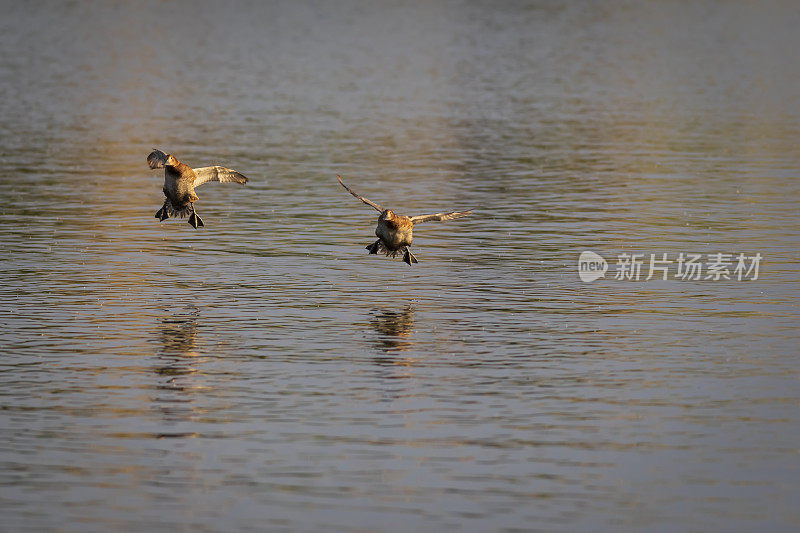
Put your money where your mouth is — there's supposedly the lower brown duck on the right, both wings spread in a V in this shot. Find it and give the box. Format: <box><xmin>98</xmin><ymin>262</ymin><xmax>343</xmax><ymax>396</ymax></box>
<box><xmin>336</xmin><ymin>174</ymin><xmax>472</xmax><ymax>266</ymax></box>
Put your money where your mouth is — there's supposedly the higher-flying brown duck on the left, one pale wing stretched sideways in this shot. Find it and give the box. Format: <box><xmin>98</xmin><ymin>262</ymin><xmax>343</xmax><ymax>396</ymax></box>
<box><xmin>147</xmin><ymin>148</ymin><xmax>247</xmax><ymax>229</ymax></box>
